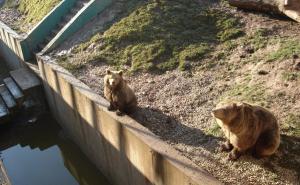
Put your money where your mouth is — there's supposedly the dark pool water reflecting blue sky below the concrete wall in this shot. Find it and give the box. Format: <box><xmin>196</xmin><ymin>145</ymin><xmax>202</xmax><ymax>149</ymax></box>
<box><xmin>0</xmin><ymin>115</ymin><xmax>109</xmax><ymax>185</ymax></box>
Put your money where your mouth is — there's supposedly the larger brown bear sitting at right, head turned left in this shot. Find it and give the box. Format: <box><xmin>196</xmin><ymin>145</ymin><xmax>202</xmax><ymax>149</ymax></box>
<box><xmin>212</xmin><ymin>103</ymin><xmax>280</xmax><ymax>160</ymax></box>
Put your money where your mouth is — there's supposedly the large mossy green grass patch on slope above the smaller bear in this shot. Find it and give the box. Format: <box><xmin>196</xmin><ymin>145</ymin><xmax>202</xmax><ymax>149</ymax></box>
<box><xmin>75</xmin><ymin>0</ymin><xmax>243</xmax><ymax>72</ymax></box>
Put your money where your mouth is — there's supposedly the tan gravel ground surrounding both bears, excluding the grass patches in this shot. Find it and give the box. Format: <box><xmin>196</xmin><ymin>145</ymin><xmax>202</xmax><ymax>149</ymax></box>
<box><xmin>51</xmin><ymin>1</ymin><xmax>300</xmax><ymax>185</ymax></box>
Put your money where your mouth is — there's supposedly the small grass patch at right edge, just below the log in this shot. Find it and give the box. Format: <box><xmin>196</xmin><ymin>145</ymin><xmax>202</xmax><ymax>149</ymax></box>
<box><xmin>267</xmin><ymin>39</ymin><xmax>300</xmax><ymax>62</ymax></box>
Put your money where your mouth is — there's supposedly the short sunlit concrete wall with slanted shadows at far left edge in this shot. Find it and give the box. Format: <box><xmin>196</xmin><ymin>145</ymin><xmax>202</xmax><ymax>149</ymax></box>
<box><xmin>0</xmin><ymin>21</ymin><xmax>24</xmax><ymax>69</ymax></box>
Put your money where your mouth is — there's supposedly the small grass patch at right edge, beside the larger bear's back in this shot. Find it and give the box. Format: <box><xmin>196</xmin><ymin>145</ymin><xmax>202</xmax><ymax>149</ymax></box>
<box><xmin>282</xmin><ymin>114</ymin><xmax>300</xmax><ymax>137</ymax></box>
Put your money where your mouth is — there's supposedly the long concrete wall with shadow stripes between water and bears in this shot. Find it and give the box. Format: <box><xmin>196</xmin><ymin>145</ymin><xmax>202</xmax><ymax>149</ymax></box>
<box><xmin>38</xmin><ymin>56</ymin><xmax>220</xmax><ymax>185</ymax></box>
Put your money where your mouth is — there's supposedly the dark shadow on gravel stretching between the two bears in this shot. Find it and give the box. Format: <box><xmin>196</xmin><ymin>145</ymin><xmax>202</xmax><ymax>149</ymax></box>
<box><xmin>130</xmin><ymin>107</ymin><xmax>221</xmax><ymax>152</ymax></box>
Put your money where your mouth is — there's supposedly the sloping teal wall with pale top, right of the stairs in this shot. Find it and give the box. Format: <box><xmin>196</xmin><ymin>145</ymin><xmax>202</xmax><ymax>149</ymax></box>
<box><xmin>41</xmin><ymin>0</ymin><xmax>112</xmax><ymax>53</ymax></box>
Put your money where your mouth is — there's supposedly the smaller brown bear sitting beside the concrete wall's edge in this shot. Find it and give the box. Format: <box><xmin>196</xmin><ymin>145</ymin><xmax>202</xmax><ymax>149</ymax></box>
<box><xmin>104</xmin><ymin>70</ymin><xmax>137</xmax><ymax>115</ymax></box>
